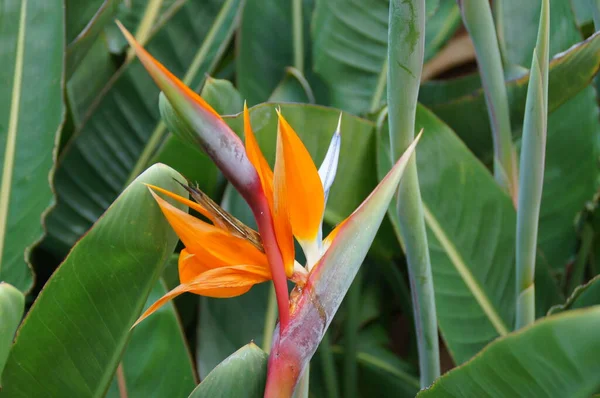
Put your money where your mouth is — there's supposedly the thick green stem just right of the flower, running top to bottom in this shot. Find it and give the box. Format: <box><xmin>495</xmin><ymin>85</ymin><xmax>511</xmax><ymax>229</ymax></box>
<box><xmin>387</xmin><ymin>0</ymin><xmax>440</xmax><ymax>388</ymax></box>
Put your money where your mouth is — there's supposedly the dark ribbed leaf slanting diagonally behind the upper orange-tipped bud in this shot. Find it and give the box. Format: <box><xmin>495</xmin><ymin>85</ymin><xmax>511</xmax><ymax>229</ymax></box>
<box><xmin>45</xmin><ymin>0</ymin><xmax>241</xmax><ymax>255</ymax></box>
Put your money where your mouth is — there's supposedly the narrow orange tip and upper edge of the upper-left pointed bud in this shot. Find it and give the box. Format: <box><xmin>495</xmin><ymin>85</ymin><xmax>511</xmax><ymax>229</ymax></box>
<box><xmin>116</xmin><ymin>21</ymin><xmax>222</xmax><ymax>120</ymax></box>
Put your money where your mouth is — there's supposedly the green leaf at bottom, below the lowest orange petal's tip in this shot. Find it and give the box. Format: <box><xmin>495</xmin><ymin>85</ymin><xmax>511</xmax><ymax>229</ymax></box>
<box><xmin>106</xmin><ymin>281</ymin><xmax>196</xmax><ymax>398</ymax></box>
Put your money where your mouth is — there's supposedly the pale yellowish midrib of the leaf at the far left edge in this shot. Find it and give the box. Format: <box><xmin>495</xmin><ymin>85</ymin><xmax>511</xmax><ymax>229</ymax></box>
<box><xmin>0</xmin><ymin>0</ymin><xmax>27</xmax><ymax>271</ymax></box>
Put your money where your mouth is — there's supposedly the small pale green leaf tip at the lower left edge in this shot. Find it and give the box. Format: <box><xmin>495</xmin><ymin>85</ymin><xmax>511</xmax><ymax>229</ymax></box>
<box><xmin>0</xmin><ymin>282</ymin><xmax>25</xmax><ymax>388</ymax></box>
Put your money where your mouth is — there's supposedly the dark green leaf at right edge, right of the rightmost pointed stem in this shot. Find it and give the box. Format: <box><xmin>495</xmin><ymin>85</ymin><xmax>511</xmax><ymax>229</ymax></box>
<box><xmin>538</xmin><ymin>87</ymin><xmax>600</xmax><ymax>270</ymax></box>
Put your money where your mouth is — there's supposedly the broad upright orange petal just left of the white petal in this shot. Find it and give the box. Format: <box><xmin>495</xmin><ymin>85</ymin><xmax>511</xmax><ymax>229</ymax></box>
<box><xmin>277</xmin><ymin>112</ymin><xmax>325</xmax><ymax>242</ymax></box>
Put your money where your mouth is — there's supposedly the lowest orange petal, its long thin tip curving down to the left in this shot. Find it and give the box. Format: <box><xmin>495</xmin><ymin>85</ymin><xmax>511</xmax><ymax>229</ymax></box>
<box><xmin>132</xmin><ymin>265</ymin><xmax>271</xmax><ymax>328</ymax></box>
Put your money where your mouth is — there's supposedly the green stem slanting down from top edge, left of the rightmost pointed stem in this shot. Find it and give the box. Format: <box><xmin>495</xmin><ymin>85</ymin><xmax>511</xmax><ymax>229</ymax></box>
<box><xmin>459</xmin><ymin>0</ymin><xmax>518</xmax><ymax>207</ymax></box>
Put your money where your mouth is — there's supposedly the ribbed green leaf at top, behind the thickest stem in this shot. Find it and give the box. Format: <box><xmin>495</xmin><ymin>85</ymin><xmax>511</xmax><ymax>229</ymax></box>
<box><xmin>313</xmin><ymin>0</ymin><xmax>460</xmax><ymax>113</ymax></box>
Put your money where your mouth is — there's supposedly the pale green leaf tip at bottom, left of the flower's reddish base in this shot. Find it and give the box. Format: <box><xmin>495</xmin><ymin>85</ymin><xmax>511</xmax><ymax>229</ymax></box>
<box><xmin>190</xmin><ymin>343</ymin><xmax>267</xmax><ymax>398</ymax></box>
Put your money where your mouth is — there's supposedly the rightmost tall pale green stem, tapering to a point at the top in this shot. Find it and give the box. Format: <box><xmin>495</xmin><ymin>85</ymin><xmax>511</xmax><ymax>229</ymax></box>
<box><xmin>515</xmin><ymin>0</ymin><xmax>550</xmax><ymax>329</ymax></box>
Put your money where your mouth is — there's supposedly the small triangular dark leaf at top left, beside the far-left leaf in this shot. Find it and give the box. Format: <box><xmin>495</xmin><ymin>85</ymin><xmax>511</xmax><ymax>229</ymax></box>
<box><xmin>65</xmin><ymin>0</ymin><xmax>120</xmax><ymax>79</ymax></box>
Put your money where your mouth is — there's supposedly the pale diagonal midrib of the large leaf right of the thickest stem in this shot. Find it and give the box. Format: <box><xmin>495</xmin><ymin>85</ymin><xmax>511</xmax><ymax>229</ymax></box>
<box><xmin>423</xmin><ymin>203</ymin><xmax>509</xmax><ymax>336</ymax></box>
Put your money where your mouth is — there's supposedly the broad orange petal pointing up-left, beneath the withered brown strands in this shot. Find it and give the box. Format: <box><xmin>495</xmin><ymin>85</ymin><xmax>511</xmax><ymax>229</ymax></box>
<box><xmin>150</xmin><ymin>190</ymin><xmax>267</xmax><ymax>266</ymax></box>
